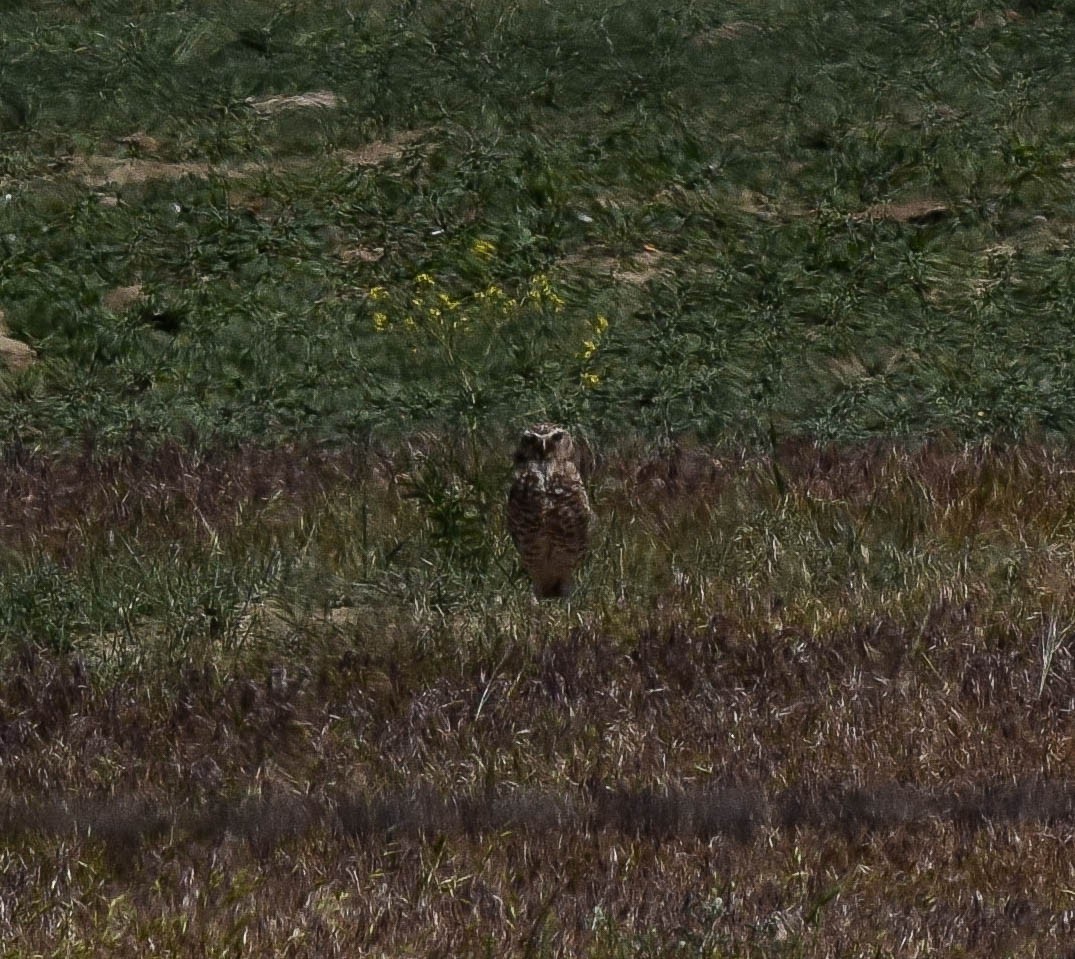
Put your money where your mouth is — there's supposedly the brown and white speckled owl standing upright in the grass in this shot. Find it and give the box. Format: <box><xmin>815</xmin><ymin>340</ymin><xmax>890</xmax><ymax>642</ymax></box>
<box><xmin>507</xmin><ymin>423</ymin><xmax>593</xmax><ymax>599</ymax></box>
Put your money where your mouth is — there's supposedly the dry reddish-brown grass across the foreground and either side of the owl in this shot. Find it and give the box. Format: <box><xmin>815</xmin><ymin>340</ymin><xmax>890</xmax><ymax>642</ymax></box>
<box><xmin>0</xmin><ymin>444</ymin><xmax>1075</xmax><ymax>956</ymax></box>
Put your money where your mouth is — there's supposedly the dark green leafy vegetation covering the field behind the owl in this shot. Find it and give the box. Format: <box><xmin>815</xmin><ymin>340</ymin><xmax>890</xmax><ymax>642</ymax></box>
<box><xmin>6</xmin><ymin>2</ymin><xmax>1075</xmax><ymax>447</ymax></box>
